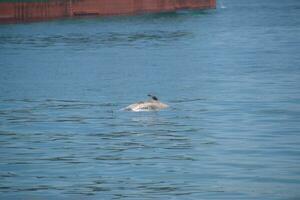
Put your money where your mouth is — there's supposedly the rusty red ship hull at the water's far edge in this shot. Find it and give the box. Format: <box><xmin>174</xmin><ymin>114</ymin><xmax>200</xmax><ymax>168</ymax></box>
<box><xmin>0</xmin><ymin>0</ymin><xmax>216</xmax><ymax>23</ymax></box>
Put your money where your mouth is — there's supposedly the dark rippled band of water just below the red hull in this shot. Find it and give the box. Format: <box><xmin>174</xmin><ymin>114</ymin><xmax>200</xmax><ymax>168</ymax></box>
<box><xmin>0</xmin><ymin>30</ymin><xmax>192</xmax><ymax>48</ymax></box>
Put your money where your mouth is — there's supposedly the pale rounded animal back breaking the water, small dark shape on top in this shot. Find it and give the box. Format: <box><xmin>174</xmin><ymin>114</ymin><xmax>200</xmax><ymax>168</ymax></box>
<box><xmin>124</xmin><ymin>94</ymin><xmax>169</xmax><ymax>112</ymax></box>
